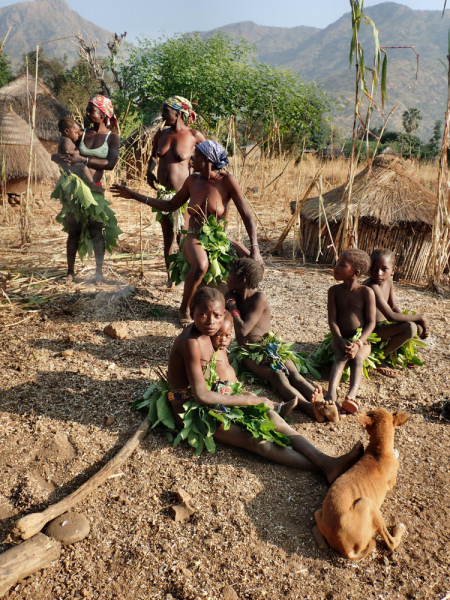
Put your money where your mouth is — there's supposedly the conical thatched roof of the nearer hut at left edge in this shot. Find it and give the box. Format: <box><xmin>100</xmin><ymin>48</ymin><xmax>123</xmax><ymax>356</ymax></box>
<box><xmin>0</xmin><ymin>107</ymin><xmax>59</xmax><ymax>181</ymax></box>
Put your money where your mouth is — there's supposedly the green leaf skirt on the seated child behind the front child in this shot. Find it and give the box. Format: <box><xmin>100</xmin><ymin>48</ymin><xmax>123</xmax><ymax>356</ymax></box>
<box><xmin>229</xmin><ymin>331</ymin><xmax>321</xmax><ymax>382</ymax></box>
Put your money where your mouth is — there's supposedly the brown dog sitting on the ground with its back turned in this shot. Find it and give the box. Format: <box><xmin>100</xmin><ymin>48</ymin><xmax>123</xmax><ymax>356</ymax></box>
<box><xmin>314</xmin><ymin>408</ymin><xmax>411</xmax><ymax>560</ymax></box>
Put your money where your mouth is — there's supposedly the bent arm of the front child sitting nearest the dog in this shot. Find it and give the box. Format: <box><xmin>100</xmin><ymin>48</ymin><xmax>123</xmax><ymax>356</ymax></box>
<box><xmin>182</xmin><ymin>339</ymin><xmax>275</xmax><ymax>409</ymax></box>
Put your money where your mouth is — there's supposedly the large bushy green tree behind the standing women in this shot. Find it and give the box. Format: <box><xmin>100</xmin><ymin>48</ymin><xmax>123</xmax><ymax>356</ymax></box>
<box><xmin>115</xmin><ymin>34</ymin><xmax>329</xmax><ymax>149</ymax></box>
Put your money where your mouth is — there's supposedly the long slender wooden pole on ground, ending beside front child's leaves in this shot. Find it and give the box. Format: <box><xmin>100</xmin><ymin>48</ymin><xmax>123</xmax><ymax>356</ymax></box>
<box><xmin>11</xmin><ymin>418</ymin><xmax>150</xmax><ymax>540</ymax></box>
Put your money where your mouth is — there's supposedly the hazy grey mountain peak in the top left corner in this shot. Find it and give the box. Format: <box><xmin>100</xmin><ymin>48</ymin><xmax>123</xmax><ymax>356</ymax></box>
<box><xmin>0</xmin><ymin>0</ymin><xmax>112</xmax><ymax>64</ymax></box>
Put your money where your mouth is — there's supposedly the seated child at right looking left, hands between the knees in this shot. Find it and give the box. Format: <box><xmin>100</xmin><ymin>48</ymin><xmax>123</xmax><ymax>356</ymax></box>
<box><xmin>325</xmin><ymin>249</ymin><xmax>375</xmax><ymax>413</ymax></box>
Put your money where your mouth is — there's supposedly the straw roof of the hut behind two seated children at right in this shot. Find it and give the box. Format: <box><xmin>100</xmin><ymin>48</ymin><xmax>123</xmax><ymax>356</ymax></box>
<box><xmin>301</xmin><ymin>155</ymin><xmax>436</xmax><ymax>227</ymax></box>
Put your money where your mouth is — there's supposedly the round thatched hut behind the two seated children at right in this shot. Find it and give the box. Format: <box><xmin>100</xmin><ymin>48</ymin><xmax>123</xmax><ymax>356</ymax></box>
<box><xmin>300</xmin><ymin>155</ymin><xmax>436</xmax><ymax>282</ymax></box>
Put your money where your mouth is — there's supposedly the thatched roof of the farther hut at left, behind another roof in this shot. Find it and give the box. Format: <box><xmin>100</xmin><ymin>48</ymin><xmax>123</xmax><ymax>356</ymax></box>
<box><xmin>0</xmin><ymin>75</ymin><xmax>70</xmax><ymax>141</ymax></box>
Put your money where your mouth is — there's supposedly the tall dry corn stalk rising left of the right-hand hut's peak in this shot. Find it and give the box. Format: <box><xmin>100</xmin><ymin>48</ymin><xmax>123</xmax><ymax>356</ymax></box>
<box><xmin>336</xmin><ymin>0</ymin><xmax>387</xmax><ymax>252</ymax></box>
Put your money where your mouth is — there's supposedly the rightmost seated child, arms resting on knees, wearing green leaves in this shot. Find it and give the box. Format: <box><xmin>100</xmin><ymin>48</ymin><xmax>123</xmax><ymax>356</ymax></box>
<box><xmin>364</xmin><ymin>248</ymin><xmax>428</xmax><ymax>377</ymax></box>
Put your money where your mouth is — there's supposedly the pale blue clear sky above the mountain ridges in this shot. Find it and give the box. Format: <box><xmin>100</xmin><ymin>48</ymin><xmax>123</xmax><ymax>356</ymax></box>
<box><xmin>0</xmin><ymin>0</ymin><xmax>450</xmax><ymax>41</ymax></box>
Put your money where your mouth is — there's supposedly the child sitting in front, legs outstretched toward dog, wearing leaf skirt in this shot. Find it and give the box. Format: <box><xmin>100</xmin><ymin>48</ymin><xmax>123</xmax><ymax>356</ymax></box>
<box><xmin>134</xmin><ymin>287</ymin><xmax>363</xmax><ymax>483</ymax></box>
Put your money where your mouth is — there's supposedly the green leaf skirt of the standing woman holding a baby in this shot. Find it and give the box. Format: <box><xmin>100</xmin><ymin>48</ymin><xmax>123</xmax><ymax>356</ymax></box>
<box><xmin>51</xmin><ymin>171</ymin><xmax>122</xmax><ymax>260</ymax></box>
